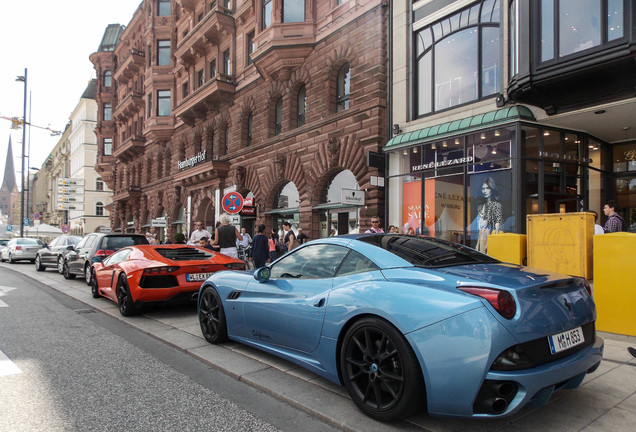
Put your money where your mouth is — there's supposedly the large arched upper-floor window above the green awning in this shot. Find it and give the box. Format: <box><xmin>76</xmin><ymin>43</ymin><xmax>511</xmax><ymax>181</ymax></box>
<box><xmin>415</xmin><ymin>0</ymin><xmax>501</xmax><ymax>116</ymax></box>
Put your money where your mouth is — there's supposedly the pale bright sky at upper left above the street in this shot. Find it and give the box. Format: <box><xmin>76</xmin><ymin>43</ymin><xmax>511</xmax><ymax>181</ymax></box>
<box><xmin>0</xmin><ymin>0</ymin><xmax>141</xmax><ymax>188</ymax></box>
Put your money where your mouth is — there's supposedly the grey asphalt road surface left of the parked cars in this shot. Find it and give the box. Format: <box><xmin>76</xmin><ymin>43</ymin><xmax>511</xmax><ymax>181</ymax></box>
<box><xmin>0</xmin><ymin>264</ymin><xmax>334</xmax><ymax>432</ymax></box>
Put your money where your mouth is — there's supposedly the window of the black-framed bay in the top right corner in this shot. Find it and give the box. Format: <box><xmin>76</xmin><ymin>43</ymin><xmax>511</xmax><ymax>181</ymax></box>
<box><xmin>540</xmin><ymin>0</ymin><xmax>625</xmax><ymax>61</ymax></box>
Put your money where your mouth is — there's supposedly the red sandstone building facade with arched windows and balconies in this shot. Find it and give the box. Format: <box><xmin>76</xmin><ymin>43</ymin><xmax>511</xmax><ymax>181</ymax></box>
<box><xmin>91</xmin><ymin>0</ymin><xmax>388</xmax><ymax>239</ymax></box>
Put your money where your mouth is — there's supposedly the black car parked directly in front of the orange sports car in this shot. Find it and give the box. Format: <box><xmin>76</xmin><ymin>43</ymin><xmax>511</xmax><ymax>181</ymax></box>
<box><xmin>62</xmin><ymin>233</ymin><xmax>148</xmax><ymax>285</ymax></box>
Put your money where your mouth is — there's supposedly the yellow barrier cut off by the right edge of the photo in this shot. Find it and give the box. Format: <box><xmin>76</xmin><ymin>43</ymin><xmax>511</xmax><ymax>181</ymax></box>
<box><xmin>594</xmin><ymin>232</ymin><xmax>636</xmax><ymax>336</ymax></box>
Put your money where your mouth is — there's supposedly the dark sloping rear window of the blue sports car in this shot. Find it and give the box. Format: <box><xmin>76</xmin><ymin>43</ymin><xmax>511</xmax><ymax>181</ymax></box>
<box><xmin>359</xmin><ymin>234</ymin><xmax>499</xmax><ymax>268</ymax></box>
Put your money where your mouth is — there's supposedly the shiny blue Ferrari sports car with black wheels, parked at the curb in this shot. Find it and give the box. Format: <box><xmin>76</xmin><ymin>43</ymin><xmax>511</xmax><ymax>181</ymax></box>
<box><xmin>198</xmin><ymin>234</ymin><xmax>603</xmax><ymax>421</ymax></box>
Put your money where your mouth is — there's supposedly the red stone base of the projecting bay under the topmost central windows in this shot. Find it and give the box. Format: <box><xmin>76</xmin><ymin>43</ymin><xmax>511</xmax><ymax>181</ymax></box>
<box><xmin>252</xmin><ymin>22</ymin><xmax>316</xmax><ymax>81</ymax></box>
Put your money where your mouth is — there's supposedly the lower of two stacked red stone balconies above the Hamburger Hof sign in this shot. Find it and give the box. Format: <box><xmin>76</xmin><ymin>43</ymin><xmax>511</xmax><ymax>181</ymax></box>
<box><xmin>174</xmin><ymin>74</ymin><xmax>236</xmax><ymax>125</ymax></box>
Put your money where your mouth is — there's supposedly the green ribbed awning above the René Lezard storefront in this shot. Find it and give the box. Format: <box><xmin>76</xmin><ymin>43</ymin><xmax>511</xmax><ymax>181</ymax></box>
<box><xmin>383</xmin><ymin>105</ymin><xmax>536</xmax><ymax>151</ymax></box>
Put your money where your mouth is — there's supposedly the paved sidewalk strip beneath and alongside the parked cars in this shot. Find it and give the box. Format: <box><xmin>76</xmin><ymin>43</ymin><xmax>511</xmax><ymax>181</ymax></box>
<box><xmin>6</xmin><ymin>263</ymin><xmax>636</xmax><ymax>432</ymax></box>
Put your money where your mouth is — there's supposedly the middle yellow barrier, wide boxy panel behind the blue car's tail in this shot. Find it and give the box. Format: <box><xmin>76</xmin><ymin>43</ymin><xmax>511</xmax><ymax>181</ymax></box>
<box><xmin>524</xmin><ymin>212</ymin><xmax>594</xmax><ymax>279</ymax></box>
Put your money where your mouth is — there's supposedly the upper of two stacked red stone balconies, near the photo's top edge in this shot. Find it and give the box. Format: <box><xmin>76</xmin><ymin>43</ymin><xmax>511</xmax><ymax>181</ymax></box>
<box><xmin>174</xmin><ymin>4</ymin><xmax>235</xmax><ymax>65</ymax></box>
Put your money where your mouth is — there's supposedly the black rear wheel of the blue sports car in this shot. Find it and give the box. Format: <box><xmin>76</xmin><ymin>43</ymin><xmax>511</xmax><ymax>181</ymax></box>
<box><xmin>340</xmin><ymin>317</ymin><xmax>425</xmax><ymax>422</ymax></box>
